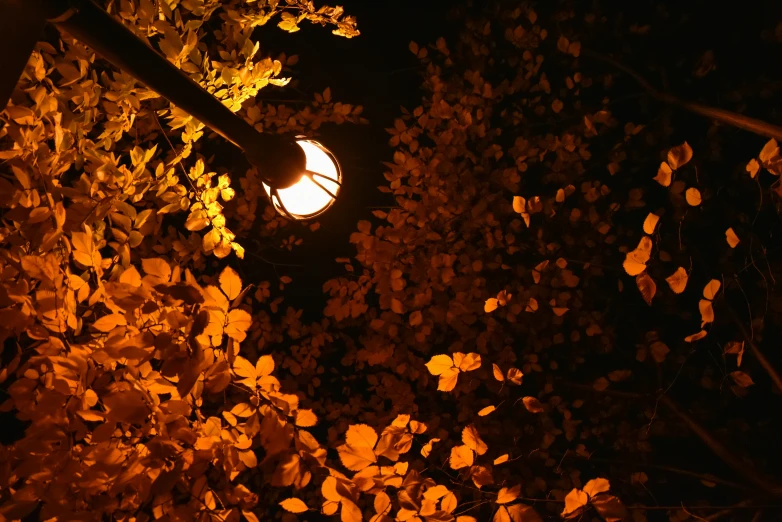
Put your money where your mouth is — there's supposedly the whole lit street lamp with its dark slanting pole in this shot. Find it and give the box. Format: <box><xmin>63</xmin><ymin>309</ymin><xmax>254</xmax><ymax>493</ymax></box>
<box><xmin>0</xmin><ymin>0</ymin><xmax>342</xmax><ymax>219</ymax></box>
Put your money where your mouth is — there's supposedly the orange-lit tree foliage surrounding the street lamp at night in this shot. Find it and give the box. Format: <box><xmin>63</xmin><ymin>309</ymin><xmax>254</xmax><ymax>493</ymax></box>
<box><xmin>0</xmin><ymin>0</ymin><xmax>782</xmax><ymax>522</ymax></box>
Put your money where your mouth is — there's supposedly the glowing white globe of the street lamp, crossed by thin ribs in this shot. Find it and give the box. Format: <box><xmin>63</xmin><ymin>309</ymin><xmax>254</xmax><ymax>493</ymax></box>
<box><xmin>263</xmin><ymin>139</ymin><xmax>342</xmax><ymax>220</ymax></box>
